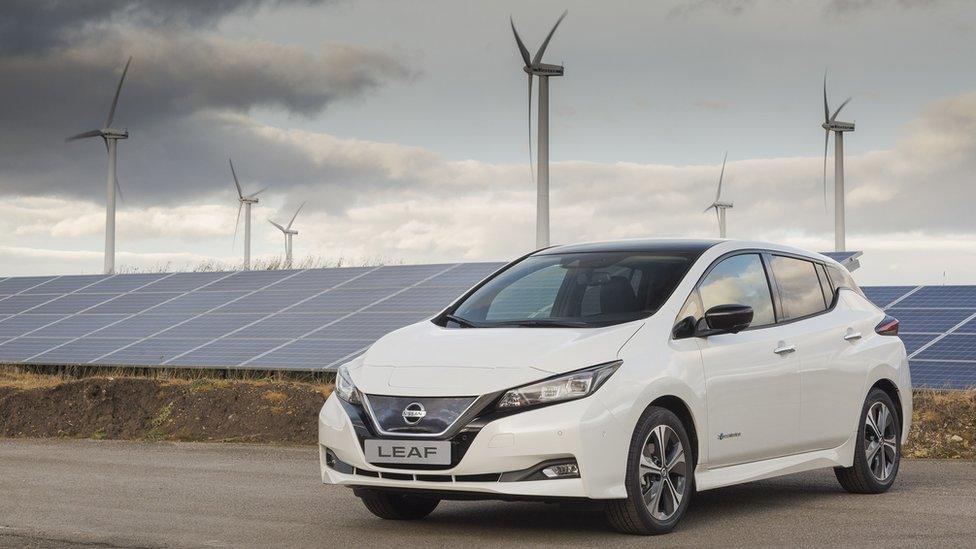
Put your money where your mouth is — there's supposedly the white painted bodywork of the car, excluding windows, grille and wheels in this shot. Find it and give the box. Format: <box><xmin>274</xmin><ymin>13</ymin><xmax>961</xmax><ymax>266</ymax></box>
<box><xmin>319</xmin><ymin>240</ymin><xmax>912</xmax><ymax>506</ymax></box>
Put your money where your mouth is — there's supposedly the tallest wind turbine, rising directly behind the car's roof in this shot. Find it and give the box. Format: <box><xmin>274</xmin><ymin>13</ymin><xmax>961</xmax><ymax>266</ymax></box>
<box><xmin>509</xmin><ymin>11</ymin><xmax>569</xmax><ymax>248</ymax></box>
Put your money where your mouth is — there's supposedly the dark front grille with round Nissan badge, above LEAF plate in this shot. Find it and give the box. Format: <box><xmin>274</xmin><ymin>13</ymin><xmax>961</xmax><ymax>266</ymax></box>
<box><xmin>365</xmin><ymin>395</ymin><xmax>476</xmax><ymax>435</ymax></box>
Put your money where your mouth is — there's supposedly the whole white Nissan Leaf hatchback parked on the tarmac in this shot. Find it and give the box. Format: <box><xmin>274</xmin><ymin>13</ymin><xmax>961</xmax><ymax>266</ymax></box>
<box><xmin>319</xmin><ymin>240</ymin><xmax>912</xmax><ymax>534</ymax></box>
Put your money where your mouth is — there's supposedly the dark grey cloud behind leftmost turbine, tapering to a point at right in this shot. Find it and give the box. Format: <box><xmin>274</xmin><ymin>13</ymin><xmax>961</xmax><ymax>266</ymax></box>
<box><xmin>0</xmin><ymin>22</ymin><xmax>415</xmax><ymax>204</ymax></box>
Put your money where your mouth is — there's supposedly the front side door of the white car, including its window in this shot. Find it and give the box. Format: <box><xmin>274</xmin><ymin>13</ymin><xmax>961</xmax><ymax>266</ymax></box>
<box><xmin>697</xmin><ymin>252</ymin><xmax>800</xmax><ymax>467</ymax></box>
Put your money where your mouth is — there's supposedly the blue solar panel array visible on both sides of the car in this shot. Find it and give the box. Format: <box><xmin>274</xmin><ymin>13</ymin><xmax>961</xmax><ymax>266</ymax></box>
<box><xmin>0</xmin><ymin>263</ymin><xmax>976</xmax><ymax>388</ymax></box>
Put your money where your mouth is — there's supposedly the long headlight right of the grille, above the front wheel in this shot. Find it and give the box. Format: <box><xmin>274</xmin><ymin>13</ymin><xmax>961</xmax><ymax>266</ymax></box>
<box><xmin>498</xmin><ymin>360</ymin><xmax>623</xmax><ymax>410</ymax></box>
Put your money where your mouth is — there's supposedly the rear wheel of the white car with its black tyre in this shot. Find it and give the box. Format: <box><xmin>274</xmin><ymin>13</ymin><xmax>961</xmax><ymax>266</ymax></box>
<box><xmin>834</xmin><ymin>389</ymin><xmax>901</xmax><ymax>494</ymax></box>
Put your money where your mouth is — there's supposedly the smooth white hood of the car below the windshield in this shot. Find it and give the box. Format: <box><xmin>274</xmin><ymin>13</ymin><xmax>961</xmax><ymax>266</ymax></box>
<box><xmin>350</xmin><ymin>321</ymin><xmax>643</xmax><ymax>396</ymax></box>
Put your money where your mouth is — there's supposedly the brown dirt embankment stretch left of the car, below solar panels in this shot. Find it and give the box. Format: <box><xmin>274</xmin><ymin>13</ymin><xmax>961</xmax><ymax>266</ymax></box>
<box><xmin>0</xmin><ymin>377</ymin><xmax>330</xmax><ymax>444</ymax></box>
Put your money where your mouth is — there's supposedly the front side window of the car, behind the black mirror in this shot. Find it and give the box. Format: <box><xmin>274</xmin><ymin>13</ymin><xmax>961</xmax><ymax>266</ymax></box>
<box><xmin>698</xmin><ymin>254</ymin><xmax>776</xmax><ymax>326</ymax></box>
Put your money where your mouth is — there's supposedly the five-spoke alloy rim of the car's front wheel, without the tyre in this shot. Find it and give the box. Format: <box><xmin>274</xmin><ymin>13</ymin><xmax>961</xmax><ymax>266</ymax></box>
<box><xmin>639</xmin><ymin>425</ymin><xmax>688</xmax><ymax>521</ymax></box>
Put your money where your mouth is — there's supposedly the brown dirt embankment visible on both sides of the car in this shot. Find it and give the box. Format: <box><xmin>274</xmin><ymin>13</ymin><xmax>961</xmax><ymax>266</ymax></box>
<box><xmin>0</xmin><ymin>372</ymin><xmax>976</xmax><ymax>459</ymax></box>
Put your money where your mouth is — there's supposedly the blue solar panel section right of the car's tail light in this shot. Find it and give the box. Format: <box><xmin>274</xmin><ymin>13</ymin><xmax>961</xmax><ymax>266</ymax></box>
<box><xmin>864</xmin><ymin>286</ymin><xmax>976</xmax><ymax>389</ymax></box>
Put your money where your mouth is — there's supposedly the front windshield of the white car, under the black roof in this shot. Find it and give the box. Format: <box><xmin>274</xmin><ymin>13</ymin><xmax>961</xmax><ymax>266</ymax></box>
<box><xmin>439</xmin><ymin>251</ymin><xmax>698</xmax><ymax>328</ymax></box>
